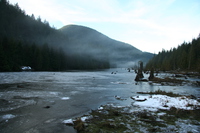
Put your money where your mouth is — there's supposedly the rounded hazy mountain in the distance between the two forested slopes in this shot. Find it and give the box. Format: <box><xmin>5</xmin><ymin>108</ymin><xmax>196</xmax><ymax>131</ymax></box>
<box><xmin>59</xmin><ymin>25</ymin><xmax>153</xmax><ymax>67</ymax></box>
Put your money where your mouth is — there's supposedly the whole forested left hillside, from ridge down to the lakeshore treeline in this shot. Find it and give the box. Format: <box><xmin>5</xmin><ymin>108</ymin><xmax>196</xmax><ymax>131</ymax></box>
<box><xmin>0</xmin><ymin>0</ymin><xmax>110</xmax><ymax>71</ymax></box>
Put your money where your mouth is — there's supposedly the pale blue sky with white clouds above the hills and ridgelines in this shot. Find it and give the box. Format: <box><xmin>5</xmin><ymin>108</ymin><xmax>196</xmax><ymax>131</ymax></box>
<box><xmin>9</xmin><ymin>0</ymin><xmax>200</xmax><ymax>53</ymax></box>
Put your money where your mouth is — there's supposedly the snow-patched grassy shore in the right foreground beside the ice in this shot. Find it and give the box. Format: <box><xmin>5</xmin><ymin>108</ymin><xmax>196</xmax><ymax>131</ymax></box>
<box><xmin>63</xmin><ymin>91</ymin><xmax>200</xmax><ymax>133</ymax></box>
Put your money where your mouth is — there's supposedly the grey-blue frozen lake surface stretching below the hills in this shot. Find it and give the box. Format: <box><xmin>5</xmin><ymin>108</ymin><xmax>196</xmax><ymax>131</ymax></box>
<box><xmin>0</xmin><ymin>68</ymin><xmax>200</xmax><ymax>133</ymax></box>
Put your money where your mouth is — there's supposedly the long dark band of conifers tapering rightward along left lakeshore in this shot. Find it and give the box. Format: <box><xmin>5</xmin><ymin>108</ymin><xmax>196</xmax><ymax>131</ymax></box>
<box><xmin>0</xmin><ymin>37</ymin><xmax>109</xmax><ymax>71</ymax></box>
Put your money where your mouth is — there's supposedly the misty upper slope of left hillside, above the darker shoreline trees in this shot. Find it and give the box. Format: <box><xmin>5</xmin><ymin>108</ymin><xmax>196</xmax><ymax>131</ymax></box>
<box><xmin>0</xmin><ymin>0</ymin><xmax>58</xmax><ymax>44</ymax></box>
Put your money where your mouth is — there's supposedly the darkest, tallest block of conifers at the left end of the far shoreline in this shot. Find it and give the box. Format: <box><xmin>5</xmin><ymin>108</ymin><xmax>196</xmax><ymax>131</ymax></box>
<box><xmin>0</xmin><ymin>37</ymin><xmax>67</xmax><ymax>71</ymax></box>
